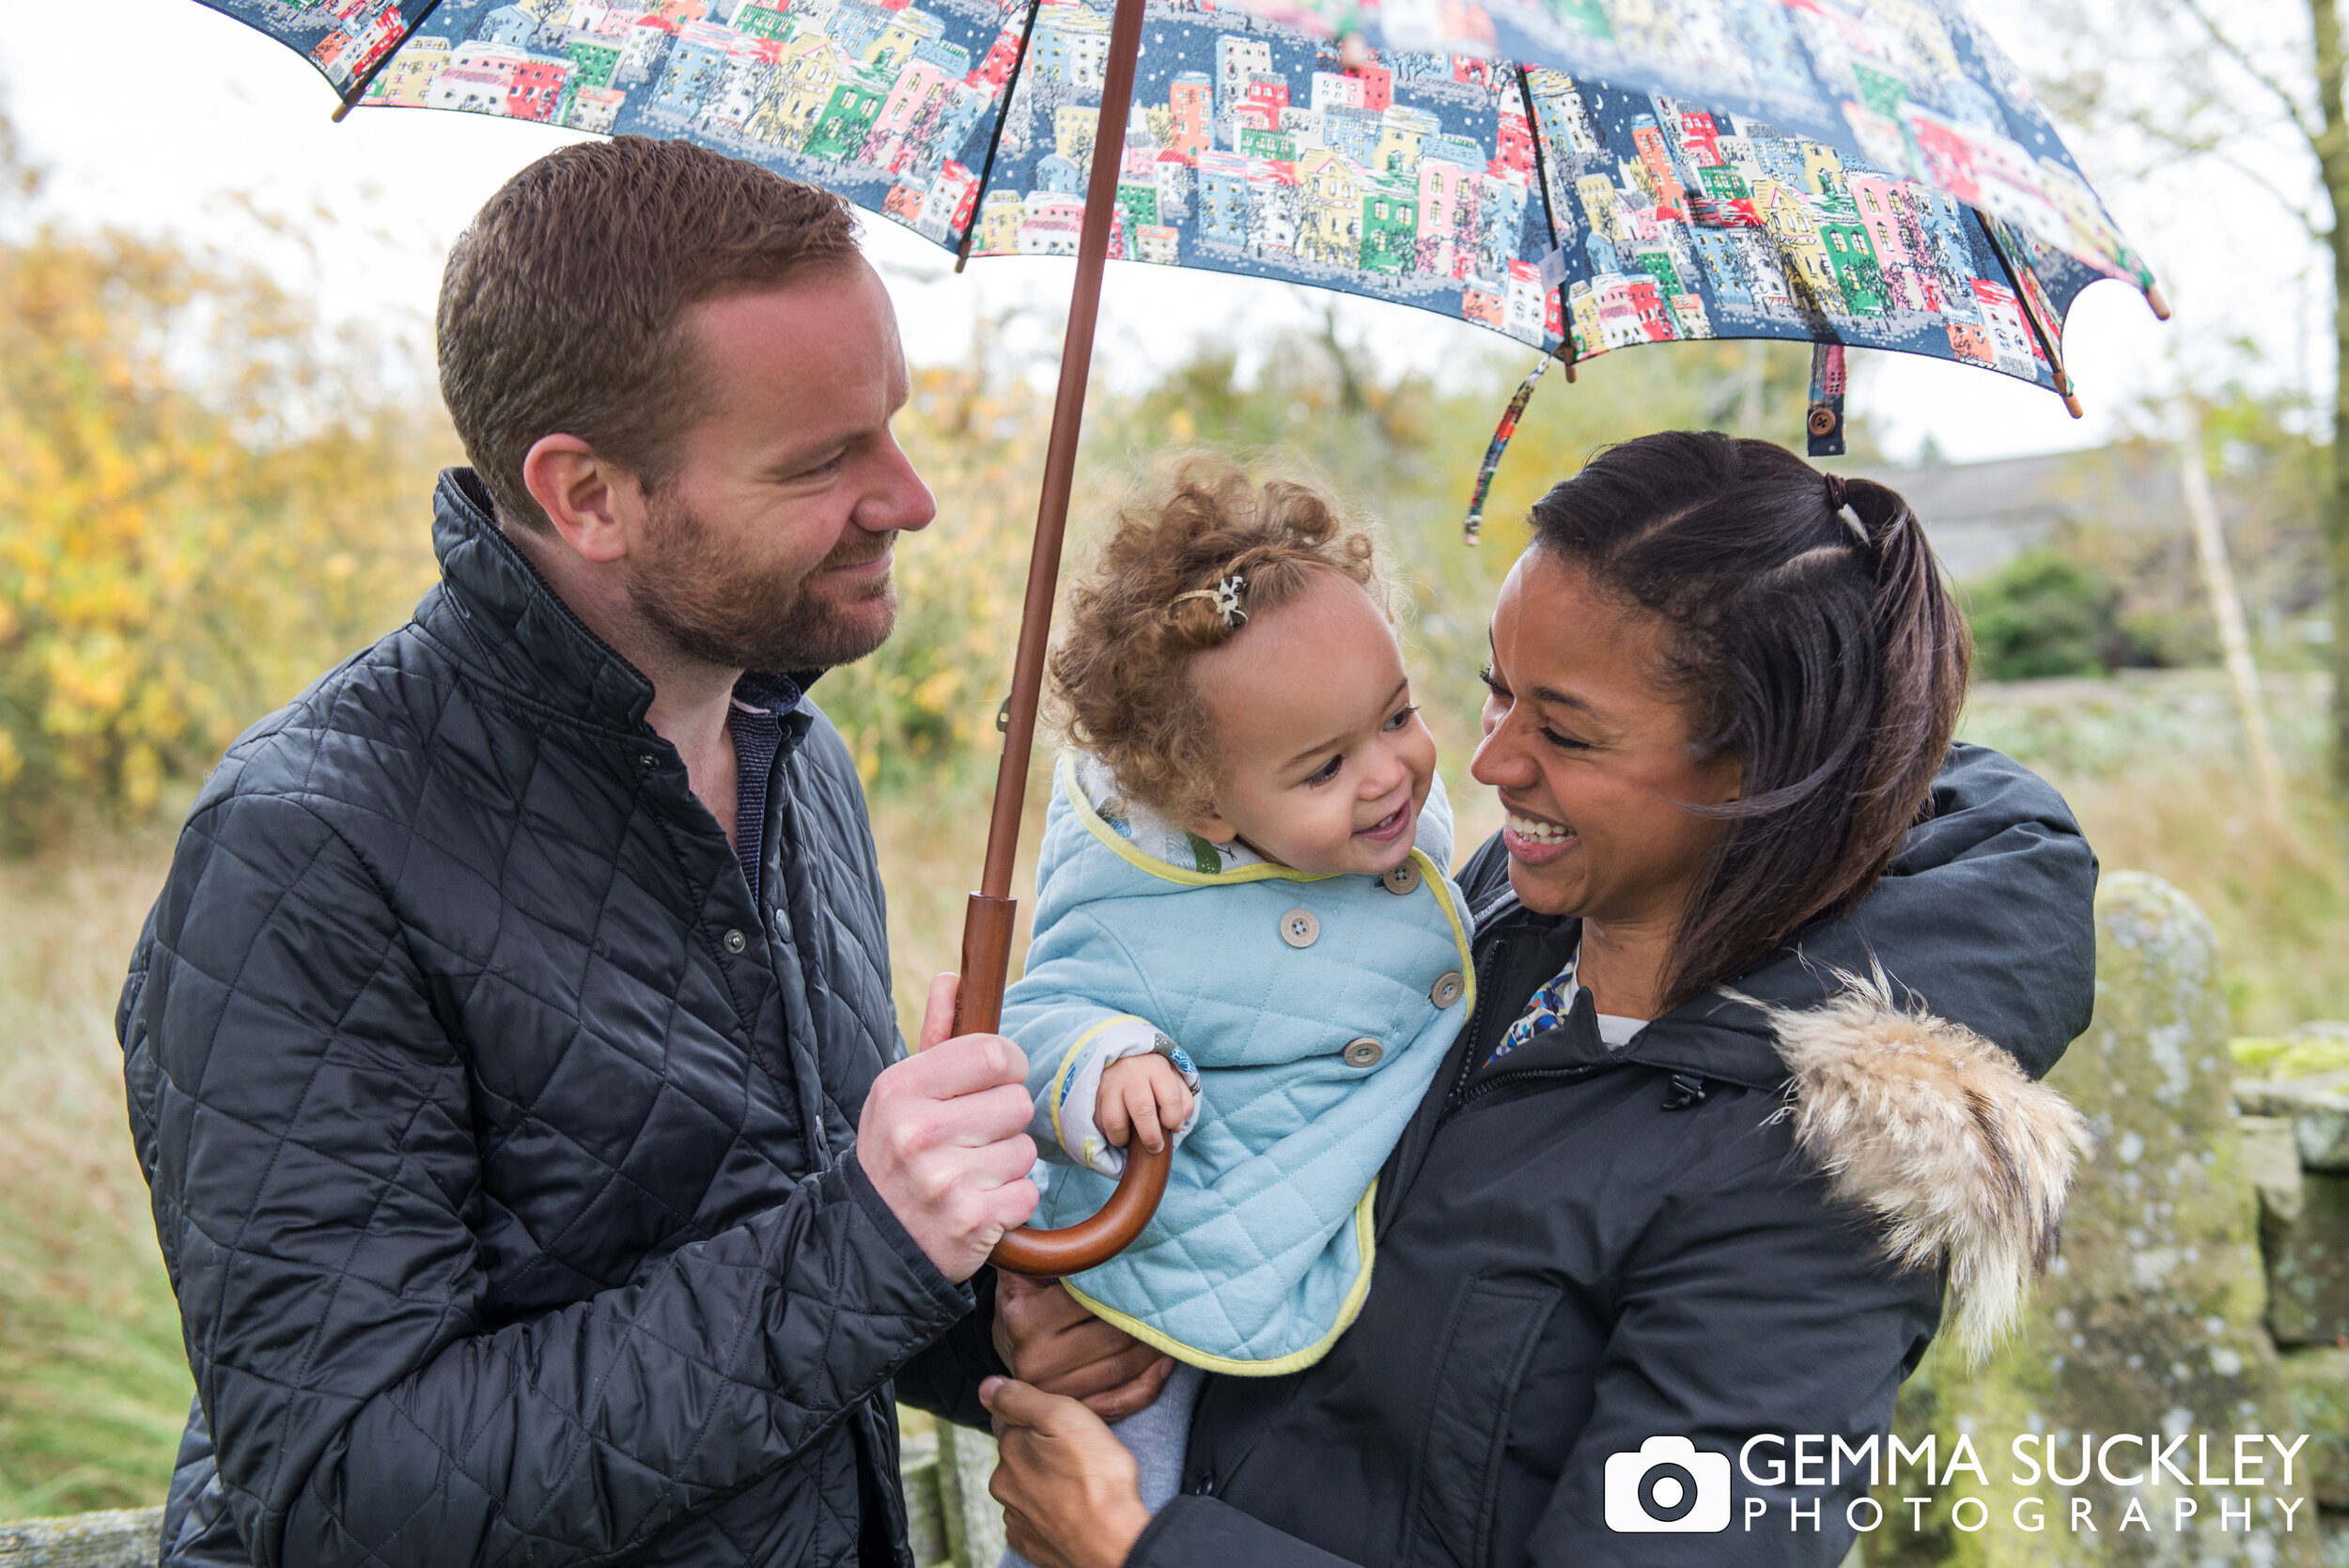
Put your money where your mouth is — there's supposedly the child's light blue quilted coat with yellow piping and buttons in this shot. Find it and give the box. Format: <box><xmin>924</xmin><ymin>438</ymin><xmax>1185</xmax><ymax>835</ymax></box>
<box><xmin>1003</xmin><ymin>756</ymin><xmax>1475</xmax><ymax>1375</ymax></box>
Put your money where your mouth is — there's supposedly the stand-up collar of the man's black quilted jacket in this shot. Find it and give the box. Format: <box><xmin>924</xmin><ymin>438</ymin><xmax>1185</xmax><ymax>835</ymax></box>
<box><xmin>428</xmin><ymin>467</ymin><xmax>820</xmax><ymax>735</ymax></box>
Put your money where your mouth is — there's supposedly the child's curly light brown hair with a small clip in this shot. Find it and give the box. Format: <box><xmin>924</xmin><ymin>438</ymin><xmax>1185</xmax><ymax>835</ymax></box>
<box><xmin>1050</xmin><ymin>453</ymin><xmax>1395</xmax><ymax>821</ymax></box>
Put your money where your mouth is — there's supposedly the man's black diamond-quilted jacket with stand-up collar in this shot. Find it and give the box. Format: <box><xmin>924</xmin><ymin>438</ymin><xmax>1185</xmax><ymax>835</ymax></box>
<box><xmin>120</xmin><ymin>470</ymin><xmax>994</xmax><ymax>1568</ymax></box>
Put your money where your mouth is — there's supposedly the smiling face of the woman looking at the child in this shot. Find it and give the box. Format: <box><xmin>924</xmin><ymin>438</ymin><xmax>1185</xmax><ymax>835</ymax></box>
<box><xmin>1469</xmin><ymin>547</ymin><xmax>1738</xmax><ymax>929</ymax></box>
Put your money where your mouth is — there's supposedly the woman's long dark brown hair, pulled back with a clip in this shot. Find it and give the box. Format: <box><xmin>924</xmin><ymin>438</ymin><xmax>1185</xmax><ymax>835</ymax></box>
<box><xmin>1534</xmin><ymin>432</ymin><xmax>1973</xmax><ymax>1002</ymax></box>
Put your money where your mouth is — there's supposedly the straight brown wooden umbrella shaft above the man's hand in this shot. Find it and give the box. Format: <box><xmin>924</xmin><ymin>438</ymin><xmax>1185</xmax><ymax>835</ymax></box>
<box><xmin>954</xmin><ymin>0</ymin><xmax>1144</xmax><ymax>1035</ymax></box>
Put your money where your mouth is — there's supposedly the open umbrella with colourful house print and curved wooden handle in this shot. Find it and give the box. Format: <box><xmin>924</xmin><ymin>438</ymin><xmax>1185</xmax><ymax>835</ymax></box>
<box><xmin>183</xmin><ymin>0</ymin><xmax>2164</xmax><ymax>1275</ymax></box>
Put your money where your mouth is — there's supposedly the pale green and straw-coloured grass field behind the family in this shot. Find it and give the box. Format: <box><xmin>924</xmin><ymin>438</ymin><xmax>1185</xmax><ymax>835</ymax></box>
<box><xmin>0</xmin><ymin>672</ymin><xmax>2349</xmax><ymax>1519</ymax></box>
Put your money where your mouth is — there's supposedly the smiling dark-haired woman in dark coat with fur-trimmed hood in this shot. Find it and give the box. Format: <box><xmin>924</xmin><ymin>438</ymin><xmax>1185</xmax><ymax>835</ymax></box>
<box><xmin>968</xmin><ymin>432</ymin><xmax>2095</xmax><ymax>1568</ymax></box>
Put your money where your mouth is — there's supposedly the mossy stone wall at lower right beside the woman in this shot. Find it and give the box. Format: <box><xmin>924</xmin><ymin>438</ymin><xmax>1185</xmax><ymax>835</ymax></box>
<box><xmin>1863</xmin><ymin>871</ymin><xmax>2349</xmax><ymax>1568</ymax></box>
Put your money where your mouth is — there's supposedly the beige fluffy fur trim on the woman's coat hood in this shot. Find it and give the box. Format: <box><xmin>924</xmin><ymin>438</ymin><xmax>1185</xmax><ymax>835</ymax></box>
<box><xmin>1741</xmin><ymin>971</ymin><xmax>2093</xmax><ymax>1361</ymax></box>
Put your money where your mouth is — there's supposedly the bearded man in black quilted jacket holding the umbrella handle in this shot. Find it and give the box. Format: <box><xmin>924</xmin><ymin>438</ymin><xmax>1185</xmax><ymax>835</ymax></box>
<box><xmin>117</xmin><ymin>138</ymin><xmax>1090</xmax><ymax>1566</ymax></box>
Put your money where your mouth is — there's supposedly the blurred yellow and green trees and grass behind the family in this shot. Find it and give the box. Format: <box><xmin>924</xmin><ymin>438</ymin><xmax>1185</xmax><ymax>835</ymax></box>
<box><xmin>0</xmin><ymin>95</ymin><xmax>2349</xmax><ymax>1519</ymax></box>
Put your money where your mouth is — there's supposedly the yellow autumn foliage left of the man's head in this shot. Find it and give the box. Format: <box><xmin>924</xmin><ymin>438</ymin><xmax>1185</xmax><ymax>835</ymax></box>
<box><xmin>0</xmin><ymin>161</ymin><xmax>454</xmax><ymax>847</ymax></box>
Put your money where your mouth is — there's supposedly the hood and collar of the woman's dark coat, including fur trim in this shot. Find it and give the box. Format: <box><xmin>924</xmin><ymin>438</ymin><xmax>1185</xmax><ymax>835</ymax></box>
<box><xmin>1461</xmin><ymin>744</ymin><xmax>2095</xmax><ymax>1357</ymax></box>
